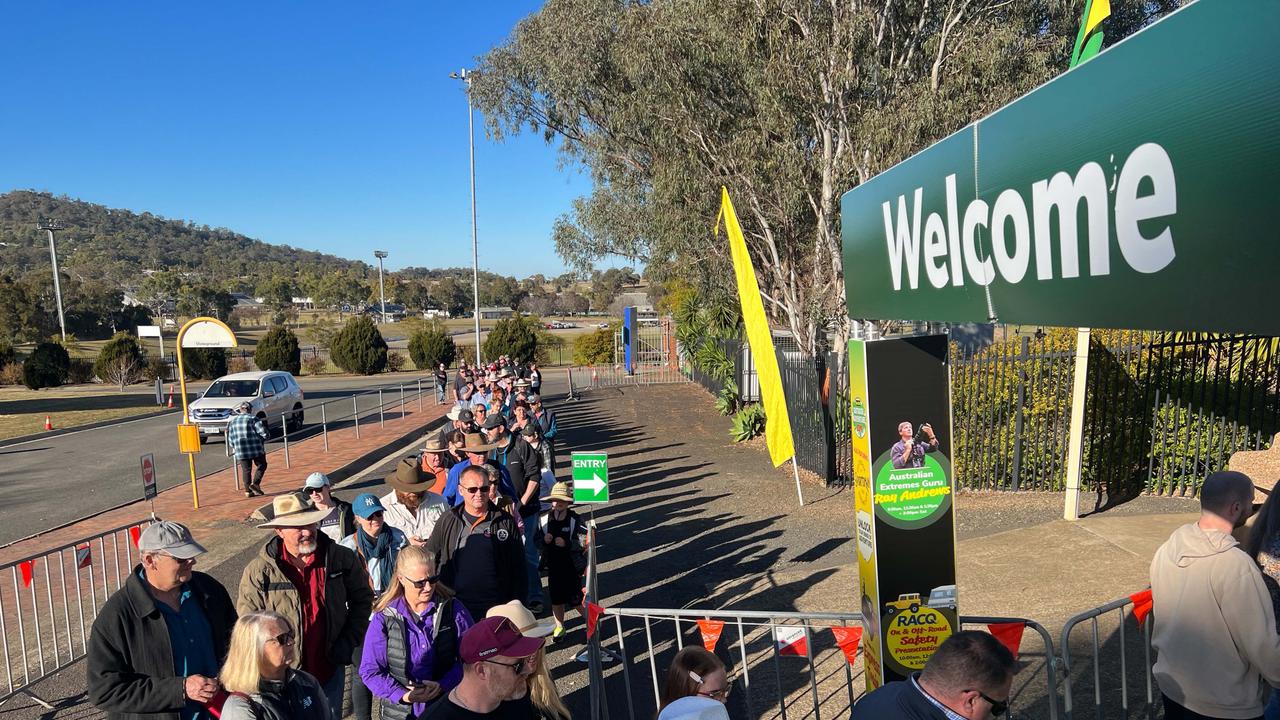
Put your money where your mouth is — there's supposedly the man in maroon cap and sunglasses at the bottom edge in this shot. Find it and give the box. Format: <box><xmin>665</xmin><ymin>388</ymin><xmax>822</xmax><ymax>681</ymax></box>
<box><xmin>420</xmin><ymin>616</ymin><xmax>545</xmax><ymax>720</ymax></box>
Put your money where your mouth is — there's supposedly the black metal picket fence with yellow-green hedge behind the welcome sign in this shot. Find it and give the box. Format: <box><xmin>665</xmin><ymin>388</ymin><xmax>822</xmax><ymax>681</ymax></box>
<box><xmin>721</xmin><ymin>328</ymin><xmax>1280</xmax><ymax>502</ymax></box>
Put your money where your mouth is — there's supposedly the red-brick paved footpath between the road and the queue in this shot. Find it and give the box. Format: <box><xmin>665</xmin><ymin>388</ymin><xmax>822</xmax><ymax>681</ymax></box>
<box><xmin>0</xmin><ymin>397</ymin><xmax>445</xmax><ymax>565</ymax></box>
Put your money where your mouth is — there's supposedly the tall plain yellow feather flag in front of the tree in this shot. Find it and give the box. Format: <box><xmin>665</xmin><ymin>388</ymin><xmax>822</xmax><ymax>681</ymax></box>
<box><xmin>716</xmin><ymin>187</ymin><xmax>795</xmax><ymax>468</ymax></box>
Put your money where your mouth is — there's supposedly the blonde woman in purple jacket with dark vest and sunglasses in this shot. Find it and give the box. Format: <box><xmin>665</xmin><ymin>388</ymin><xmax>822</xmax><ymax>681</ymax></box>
<box><xmin>360</xmin><ymin>546</ymin><xmax>472</xmax><ymax>720</ymax></box>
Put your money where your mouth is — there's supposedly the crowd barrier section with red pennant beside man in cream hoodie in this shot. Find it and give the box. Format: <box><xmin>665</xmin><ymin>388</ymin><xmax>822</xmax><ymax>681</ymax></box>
<box><xmin>1060</xmin><ymin>597</ymin><xmax>1157</xmax><ymax>720</ymax></box>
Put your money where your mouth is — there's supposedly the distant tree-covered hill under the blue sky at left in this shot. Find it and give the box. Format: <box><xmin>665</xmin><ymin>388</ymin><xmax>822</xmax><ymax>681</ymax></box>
<box><xmin>0</xmin><ymin>190</ymin><xmax>371</xmax><ymax>291</ymax></box>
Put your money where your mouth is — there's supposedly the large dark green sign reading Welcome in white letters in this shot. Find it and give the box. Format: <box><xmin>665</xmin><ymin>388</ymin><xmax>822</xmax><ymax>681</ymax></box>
<box><xmin>841</xmin><ymin>0</ymin><xmax>1280</xmax><ymax>334</ymax></box>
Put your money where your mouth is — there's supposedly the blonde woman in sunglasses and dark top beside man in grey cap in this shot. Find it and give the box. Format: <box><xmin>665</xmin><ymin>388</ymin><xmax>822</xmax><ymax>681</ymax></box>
<box><xmin>218</xmin><ymin>610</ymin><xmax>330</xmax><ymax>720</ymax></box>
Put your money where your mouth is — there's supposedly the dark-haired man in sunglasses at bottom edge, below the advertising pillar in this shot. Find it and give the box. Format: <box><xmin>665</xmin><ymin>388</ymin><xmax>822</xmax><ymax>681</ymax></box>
<box><xmin>850</xmin><ymin>630</ymin><xmax>1016</xmax><ymax>720</ymax></box>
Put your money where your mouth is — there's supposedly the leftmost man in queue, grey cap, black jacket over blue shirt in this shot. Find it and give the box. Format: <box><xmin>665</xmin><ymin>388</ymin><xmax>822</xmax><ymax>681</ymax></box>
<box><xmin>87</xmin><ymin>521</ymin><xmax>236</xmax><ymax>720</ymax></box>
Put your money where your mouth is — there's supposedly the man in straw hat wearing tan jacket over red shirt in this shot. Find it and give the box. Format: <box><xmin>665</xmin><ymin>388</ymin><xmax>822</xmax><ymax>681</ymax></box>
<box><xmin>237</xmin><ymin>493</ymin><xmax>374</xmax><ymax>720</ymax></box>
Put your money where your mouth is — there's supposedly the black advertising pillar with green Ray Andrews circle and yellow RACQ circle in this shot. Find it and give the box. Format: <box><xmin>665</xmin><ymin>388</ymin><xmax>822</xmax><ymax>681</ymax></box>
<box><xmin>849</xmin><ymin>334</ymin><xmax>959</xmax><ymax>691</ymax></box>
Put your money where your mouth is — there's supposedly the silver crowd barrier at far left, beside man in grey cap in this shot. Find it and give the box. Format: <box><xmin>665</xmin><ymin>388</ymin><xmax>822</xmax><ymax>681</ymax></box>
<box><xmin>0</xmin><ymin>518</ymin><xmax>156</xmax><ymax>710</ymax></box>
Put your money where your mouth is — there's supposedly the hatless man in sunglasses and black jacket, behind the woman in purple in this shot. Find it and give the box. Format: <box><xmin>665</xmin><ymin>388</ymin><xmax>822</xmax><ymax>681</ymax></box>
<box><xmin>426</xmin><ymin>465</ymin><xmax>529</xmax><ymax>618</ymax></box>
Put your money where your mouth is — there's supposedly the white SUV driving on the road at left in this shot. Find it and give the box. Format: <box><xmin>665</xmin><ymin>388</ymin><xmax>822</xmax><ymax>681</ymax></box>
<box><xmin>191</xmin><ymin>370</ymin><xmax>303</xmax><ymax>442</ymax></box>
